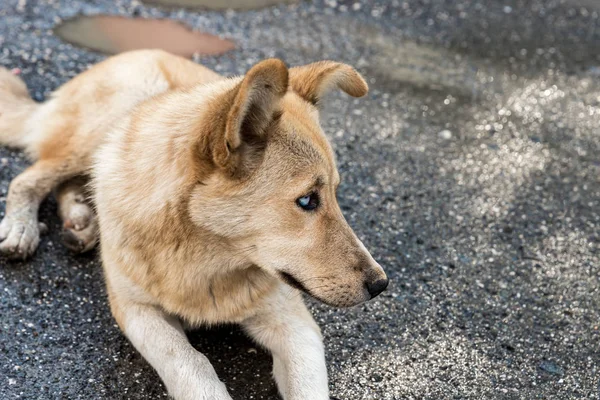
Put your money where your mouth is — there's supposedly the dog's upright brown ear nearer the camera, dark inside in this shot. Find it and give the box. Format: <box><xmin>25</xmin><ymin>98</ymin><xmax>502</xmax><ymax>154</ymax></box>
<box><xmin>211</xmin><ymin>59</ymin><xmax>288</xmax><ymax>173</ymax></box>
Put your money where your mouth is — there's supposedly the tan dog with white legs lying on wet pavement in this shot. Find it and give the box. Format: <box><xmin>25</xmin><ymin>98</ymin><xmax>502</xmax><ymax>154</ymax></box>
<box><xmin>0</xmin><ymin>51</ymin><xmax>388</xmax><ymax>400</ymax></box>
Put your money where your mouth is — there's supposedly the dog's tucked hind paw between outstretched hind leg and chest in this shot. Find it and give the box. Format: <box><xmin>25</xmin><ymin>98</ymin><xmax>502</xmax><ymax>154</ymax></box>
<box><xmin>56</xmin><ymin>176</ymin><xmax>99</xmax><ymax>253</ymax></box>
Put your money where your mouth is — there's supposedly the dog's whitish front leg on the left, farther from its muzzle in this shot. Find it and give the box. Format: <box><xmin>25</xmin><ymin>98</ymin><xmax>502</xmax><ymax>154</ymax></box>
<box><xmin>108</xmin><ymin>286</ymin><xmax>232</xmax><ymax>400</ymax></box>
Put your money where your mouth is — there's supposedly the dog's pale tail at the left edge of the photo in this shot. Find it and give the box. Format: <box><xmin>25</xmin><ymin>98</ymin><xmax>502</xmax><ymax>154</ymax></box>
<box><xmin>0</xmin><ymin>67</ymin><xmax>39</xmax><ymax>149</ymax></box>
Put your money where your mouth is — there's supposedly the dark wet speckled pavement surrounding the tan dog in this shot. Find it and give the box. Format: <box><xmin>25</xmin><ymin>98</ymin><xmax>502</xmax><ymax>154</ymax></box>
<box><xmin>0</xmin><ymin>0</ymin><xmax>600</xmax><ymax>400</ymax></box>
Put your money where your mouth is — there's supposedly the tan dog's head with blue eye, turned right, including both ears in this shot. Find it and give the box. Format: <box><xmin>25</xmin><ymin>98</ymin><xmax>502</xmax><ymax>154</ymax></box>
<box><xmin>189</xmin><ymin>59</ymin><xmax>388</xmax><ymax>306</ymax></box>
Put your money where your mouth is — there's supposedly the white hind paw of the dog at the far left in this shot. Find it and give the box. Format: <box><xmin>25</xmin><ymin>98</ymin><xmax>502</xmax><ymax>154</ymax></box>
<box><xmin>0</xmin><ymin>216</ymin><xmax>40</xmax><ymax>259</ymax></box>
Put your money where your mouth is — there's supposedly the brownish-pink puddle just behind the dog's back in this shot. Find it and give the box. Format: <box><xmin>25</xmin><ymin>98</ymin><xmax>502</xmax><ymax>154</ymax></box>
<box><xmin>54</xmin><ymin>15</ymin><xmax>235</xmax><ymax>58</ymax></box>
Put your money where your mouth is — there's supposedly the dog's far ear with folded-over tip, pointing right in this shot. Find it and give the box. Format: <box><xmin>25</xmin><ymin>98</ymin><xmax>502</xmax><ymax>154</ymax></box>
<box><xmin>290</xmin><ymin>61</ymin><xmax>369</xmax><ymax>105</ymax></box>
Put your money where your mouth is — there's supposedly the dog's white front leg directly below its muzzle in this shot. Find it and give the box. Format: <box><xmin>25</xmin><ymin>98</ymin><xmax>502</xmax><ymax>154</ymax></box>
<box><xmin>243</xmin><ymin>285</ymin><xmax>329</xmax><ymax>400</ymax></box>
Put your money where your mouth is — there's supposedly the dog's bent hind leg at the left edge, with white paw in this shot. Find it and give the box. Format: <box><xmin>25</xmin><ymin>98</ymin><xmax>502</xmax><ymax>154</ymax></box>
<box><xmin>0</xmin><ymin>159</ymin><xmax>78</xmax><ymax>258</ymax></box>
